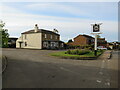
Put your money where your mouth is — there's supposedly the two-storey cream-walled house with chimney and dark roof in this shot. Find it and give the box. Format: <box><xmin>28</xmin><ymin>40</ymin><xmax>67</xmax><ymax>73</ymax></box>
<box><xmin>16</xmin><ymin>24</ymin><xmax>64</xmax><ymax>49</ymax></box>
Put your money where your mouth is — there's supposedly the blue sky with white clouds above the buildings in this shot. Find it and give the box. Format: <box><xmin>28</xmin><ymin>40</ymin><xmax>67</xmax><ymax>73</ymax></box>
<box><xmin>0</xmin><ymin>2</ymin><xmax>118</xmax><ymax>42</ymax></box>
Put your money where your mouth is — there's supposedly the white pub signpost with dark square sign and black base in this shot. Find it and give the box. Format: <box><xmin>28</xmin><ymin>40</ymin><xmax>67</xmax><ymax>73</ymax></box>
<box><xmin>91</xmin><ymin>23</ymin><xmax>102</xmax><ymax>56</ymax></box>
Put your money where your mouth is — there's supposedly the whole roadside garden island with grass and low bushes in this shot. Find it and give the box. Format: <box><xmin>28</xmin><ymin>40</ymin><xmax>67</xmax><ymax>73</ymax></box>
<box><xmin>50</xmin><ymin>49</ymin><xmax>105</xmax><ymax>59</ymax></box>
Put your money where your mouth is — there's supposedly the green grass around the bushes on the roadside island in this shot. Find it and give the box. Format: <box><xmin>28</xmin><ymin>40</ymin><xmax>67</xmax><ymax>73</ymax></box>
<box><xmin>50</xmin><ymin>51</ymin><xmax>104</xmax><ymax>58</ymax></box>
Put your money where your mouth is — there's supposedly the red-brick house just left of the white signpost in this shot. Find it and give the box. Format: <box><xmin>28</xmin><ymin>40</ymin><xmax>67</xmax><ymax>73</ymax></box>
<box><xmin>68</xmin><ymin>34</ymin><xmax>94</xmax><ymax>46</ymax></box>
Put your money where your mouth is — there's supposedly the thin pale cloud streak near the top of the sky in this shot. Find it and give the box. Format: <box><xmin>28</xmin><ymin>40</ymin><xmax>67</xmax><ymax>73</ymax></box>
<box><xmin>25</xmin><ymin>3</ymin><xmax>93</xmax><ymax>17</ymax></box>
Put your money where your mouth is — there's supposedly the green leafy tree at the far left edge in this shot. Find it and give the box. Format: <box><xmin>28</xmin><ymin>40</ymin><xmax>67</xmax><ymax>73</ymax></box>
<box><xmin>0</xmin><ymin>21</ymin><xmax>9</xmax><ymax>47</ymax></box>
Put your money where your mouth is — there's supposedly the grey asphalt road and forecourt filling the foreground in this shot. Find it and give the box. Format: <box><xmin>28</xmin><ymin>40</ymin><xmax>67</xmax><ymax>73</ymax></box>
<box><xmin>2</xmin><ymin>49</ymin><xmax>118</xmax><ymax>88</ymax></box>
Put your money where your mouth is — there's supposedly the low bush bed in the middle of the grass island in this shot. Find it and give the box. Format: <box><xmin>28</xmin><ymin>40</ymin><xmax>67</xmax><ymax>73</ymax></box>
<box><xmin>65</xmin><ymin>49</ymin><xmax>90</xmax><ymax>55</ymax></box>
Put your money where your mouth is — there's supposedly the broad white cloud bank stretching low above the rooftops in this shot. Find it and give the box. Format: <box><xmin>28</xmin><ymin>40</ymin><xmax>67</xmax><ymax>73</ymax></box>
<box><xmin>1</xmin><ymin>4</ymin><xmax>118</xmax><ymax>41</ymax></box>
